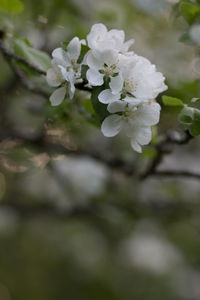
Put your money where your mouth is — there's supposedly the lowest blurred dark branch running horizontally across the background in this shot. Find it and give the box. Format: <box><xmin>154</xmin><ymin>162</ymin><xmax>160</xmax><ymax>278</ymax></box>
<box><xmin>0</xmin><ymin>198</ymin><xmax>196</xmax><ymax>221</ymax></box>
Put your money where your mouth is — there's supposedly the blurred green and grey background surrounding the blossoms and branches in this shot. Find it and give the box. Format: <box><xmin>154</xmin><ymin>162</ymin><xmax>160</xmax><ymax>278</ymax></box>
<box><xmin>0</xmin><ymin>0</ymin><xmax>200</xmax><ymax>300</ymax></box>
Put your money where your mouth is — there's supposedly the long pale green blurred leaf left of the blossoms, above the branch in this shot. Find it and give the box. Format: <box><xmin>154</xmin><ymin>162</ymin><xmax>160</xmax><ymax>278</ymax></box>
<box><xmin>14</xmin><ymin>40</ymin><xmax>51</xmax><ymax>71</ymax></box>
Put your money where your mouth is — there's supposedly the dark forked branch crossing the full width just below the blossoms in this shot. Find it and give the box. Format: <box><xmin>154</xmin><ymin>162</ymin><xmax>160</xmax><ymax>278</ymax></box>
<box><xmin>0</xmin><ymin>126</ymin><xmax>200</xmax><ymax>180</ymax></box>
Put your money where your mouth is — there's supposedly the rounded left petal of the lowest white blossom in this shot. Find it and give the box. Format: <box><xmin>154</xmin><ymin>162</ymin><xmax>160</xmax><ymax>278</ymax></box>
<box><xmin>101</xmin><ymin>115</ymin><xmax>123</xmax><ymax>137</ymax></box>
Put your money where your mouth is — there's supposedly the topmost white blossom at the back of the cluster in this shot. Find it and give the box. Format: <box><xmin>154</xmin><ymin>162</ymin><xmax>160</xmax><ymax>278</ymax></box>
<box><xmin>87</xmin><ymin>24</ymin><xmax>134</xmax><ymax>53</ymax></box>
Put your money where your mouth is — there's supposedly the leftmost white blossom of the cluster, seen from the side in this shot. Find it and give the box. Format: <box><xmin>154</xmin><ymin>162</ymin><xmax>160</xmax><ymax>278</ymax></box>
<box><xmin>47</xmin><ymin>37</ymin><xmax>84</xmax><ymax>106</ymax></box>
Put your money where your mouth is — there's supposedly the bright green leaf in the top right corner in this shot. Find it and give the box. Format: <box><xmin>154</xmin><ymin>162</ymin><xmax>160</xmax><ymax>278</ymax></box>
<box><xmin>179</xmin><ymin>2</ymin><xmax>200</xmax><ymax>25</ymax></box>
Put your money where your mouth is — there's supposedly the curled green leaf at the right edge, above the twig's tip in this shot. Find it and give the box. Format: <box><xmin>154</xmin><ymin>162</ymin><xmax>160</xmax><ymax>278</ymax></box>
<box><xmin>179</xmin><ymin>106</ymin><xmax>200</xmax><ymax>136</ymax></box>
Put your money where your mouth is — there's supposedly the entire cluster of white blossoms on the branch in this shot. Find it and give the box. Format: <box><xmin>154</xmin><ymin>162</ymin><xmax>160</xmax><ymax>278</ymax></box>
<box><xmin>47</xmin><ymin>24</ymin><xmax>167</xmax><ymax>152</ymax></box>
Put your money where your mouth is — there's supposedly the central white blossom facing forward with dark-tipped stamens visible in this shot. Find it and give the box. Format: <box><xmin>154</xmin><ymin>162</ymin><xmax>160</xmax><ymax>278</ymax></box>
<box><xmin>86</xmin><ymin>50</ymin><xmax>123</xmax><ymax>94</ymax></box>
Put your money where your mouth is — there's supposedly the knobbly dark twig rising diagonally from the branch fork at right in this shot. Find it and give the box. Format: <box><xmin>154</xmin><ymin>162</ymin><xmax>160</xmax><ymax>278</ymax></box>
<box><xmin>140</xmin><ymin>130</ymin><xmax>192</xmax><ymax>180</ymax></box>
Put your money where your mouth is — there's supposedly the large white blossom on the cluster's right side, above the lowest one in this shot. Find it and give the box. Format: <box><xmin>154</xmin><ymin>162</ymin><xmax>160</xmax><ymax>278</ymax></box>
<box><xmin>99</xmin><ymin>55</ymin><xmax>167</xmax><ymax>104</ymax></box>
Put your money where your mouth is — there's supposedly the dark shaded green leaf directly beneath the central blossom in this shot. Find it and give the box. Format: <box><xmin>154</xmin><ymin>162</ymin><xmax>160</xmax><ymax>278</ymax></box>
<box><xmin>91</xmin><ymin>86</ymin><xmax>109</xmax><ymax>122</ymax></box>
